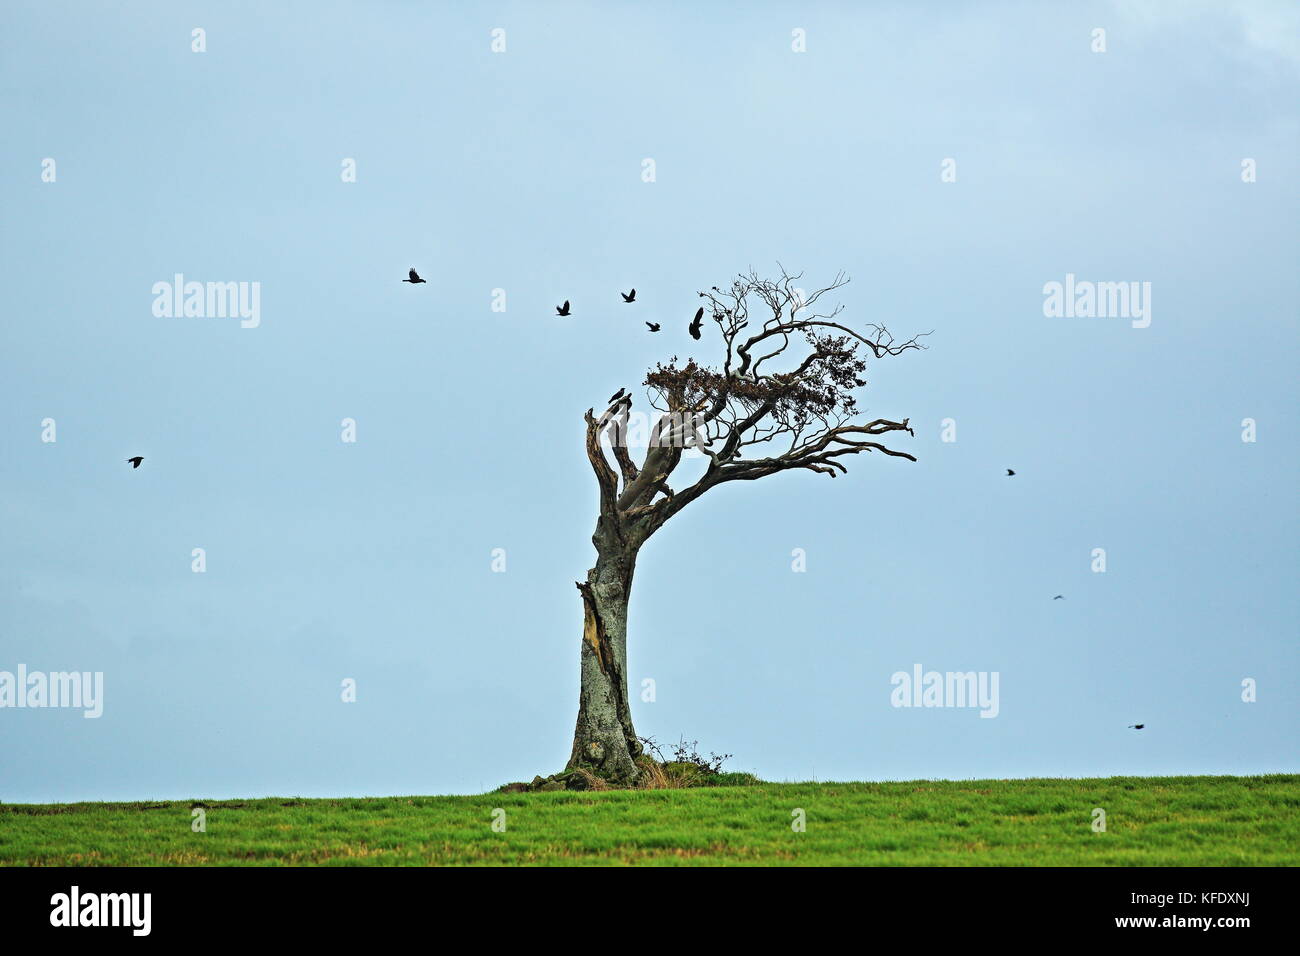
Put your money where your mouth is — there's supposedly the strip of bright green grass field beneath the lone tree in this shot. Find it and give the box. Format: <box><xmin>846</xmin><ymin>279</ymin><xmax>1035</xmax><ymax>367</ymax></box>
<box><xmin>0</xmin><ymin>774</ymin><xmax>1300</xmax><ymax>866</ymax></box>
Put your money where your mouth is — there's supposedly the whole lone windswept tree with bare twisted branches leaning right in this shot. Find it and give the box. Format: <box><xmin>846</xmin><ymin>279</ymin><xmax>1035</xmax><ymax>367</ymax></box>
<box><xmin>568</xmin><ymin>268</ymin><xmax>928</xmax><ymax>786</ymax></box>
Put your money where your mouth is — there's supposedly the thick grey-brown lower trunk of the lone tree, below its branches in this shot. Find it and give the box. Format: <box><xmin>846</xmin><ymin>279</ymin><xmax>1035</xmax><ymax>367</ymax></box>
<box><xmin>568</xmin><ymin>535</ymin><xmax>641</xmax><ymax>786</ymax></box>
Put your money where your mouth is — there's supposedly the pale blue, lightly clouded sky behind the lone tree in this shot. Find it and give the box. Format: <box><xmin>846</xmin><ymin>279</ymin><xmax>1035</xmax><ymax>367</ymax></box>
<box><xmin>0</xmin><ymin>0</ymin><xmax>1300</xmax><ymax>803</ymax></box>
